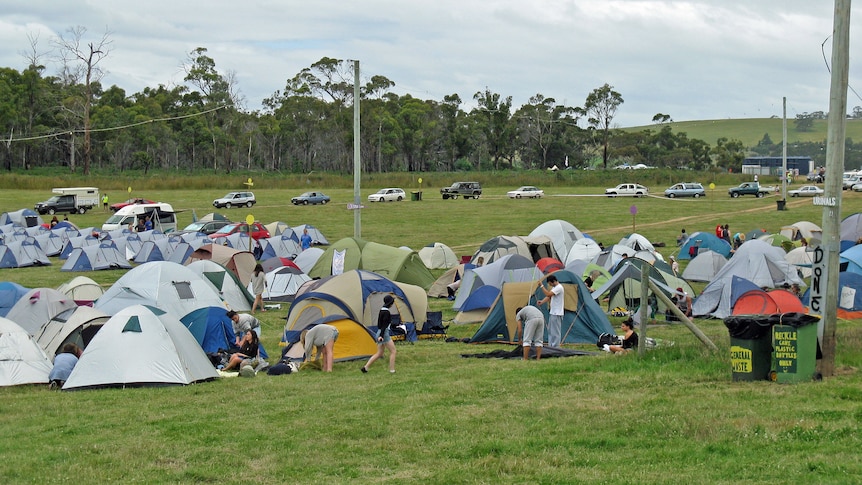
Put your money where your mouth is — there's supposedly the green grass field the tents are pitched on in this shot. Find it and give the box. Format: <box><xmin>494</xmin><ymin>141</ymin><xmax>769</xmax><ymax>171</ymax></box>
<box><xmin>0</xmin><ymin>177</ymin><xmax>862</xmax><ymax>484</ymax></box>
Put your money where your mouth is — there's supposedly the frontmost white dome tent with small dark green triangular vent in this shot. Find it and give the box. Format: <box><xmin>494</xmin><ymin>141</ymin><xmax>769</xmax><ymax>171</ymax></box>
<box><xmin>63</xmin><ymin>305</ymin><xmax>218</xmax><ymax>391</ymax></box>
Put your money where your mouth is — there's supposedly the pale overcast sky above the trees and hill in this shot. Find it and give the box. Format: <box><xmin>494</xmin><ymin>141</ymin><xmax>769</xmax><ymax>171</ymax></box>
<box><xmin>0</xmin><ymin>0</ymin><xmax>862</xmax><ymax>126</ymax></box>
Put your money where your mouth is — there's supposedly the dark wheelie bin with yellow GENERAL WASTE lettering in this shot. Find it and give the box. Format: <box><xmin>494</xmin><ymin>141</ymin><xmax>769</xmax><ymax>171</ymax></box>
<box><xmin>724</xmin><ymin>315</ymin><xmax>772</xmax><ymax>381</ymax></box>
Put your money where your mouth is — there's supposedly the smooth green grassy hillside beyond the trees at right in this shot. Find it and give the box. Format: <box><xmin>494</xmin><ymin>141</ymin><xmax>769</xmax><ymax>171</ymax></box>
<box><xmin>622</xmin><ymin>118</ymin><xmax>862</xmax><ymax>147</ymax></box>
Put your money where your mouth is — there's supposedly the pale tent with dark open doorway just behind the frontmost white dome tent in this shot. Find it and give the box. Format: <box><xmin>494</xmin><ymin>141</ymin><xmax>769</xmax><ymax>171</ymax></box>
<box><xmin>34</xmin><ymin>306</ymin><xmax>111</xmax><ymax>360</ymax></box>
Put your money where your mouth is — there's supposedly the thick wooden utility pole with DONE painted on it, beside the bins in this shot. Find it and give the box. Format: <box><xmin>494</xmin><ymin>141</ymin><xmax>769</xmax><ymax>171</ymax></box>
<box><xmin>812</xmin><ymin>0</ymin><xmax>850</xmax><ymax>377</ymax></box>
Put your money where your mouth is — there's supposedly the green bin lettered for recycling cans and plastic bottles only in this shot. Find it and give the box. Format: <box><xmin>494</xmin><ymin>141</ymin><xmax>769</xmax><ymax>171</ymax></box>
<box><xmin>769</xmin><ymin>313</ymin><xmax>820</xmax><ymax>383</ymax></box>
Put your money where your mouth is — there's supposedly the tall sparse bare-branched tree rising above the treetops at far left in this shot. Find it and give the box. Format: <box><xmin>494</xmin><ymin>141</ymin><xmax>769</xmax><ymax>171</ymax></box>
<box><xmin>53</xmin><ymin>26</ymin><xmax>113</xmax><ymax>175</ymax></box>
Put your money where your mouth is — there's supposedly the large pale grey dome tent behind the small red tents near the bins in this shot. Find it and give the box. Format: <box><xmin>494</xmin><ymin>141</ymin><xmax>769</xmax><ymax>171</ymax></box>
<box><xmin>692</xmin><ymin>239</ymin><xmax>804</xmax><ymax>318</ymax></box>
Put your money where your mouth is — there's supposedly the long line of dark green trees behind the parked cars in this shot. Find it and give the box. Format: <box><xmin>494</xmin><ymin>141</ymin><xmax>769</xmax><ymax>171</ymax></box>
<box><xmin>0</xmin><ymin>27</ymin><xmax>840</xmax><ymax>174</ymax></box>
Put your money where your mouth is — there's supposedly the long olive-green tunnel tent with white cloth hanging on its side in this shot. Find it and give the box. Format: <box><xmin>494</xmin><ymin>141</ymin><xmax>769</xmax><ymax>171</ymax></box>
<box><xmin>303</xmin><ymin>237</ymin><xmax>434</xmax><ymax>289</ymax></box>
